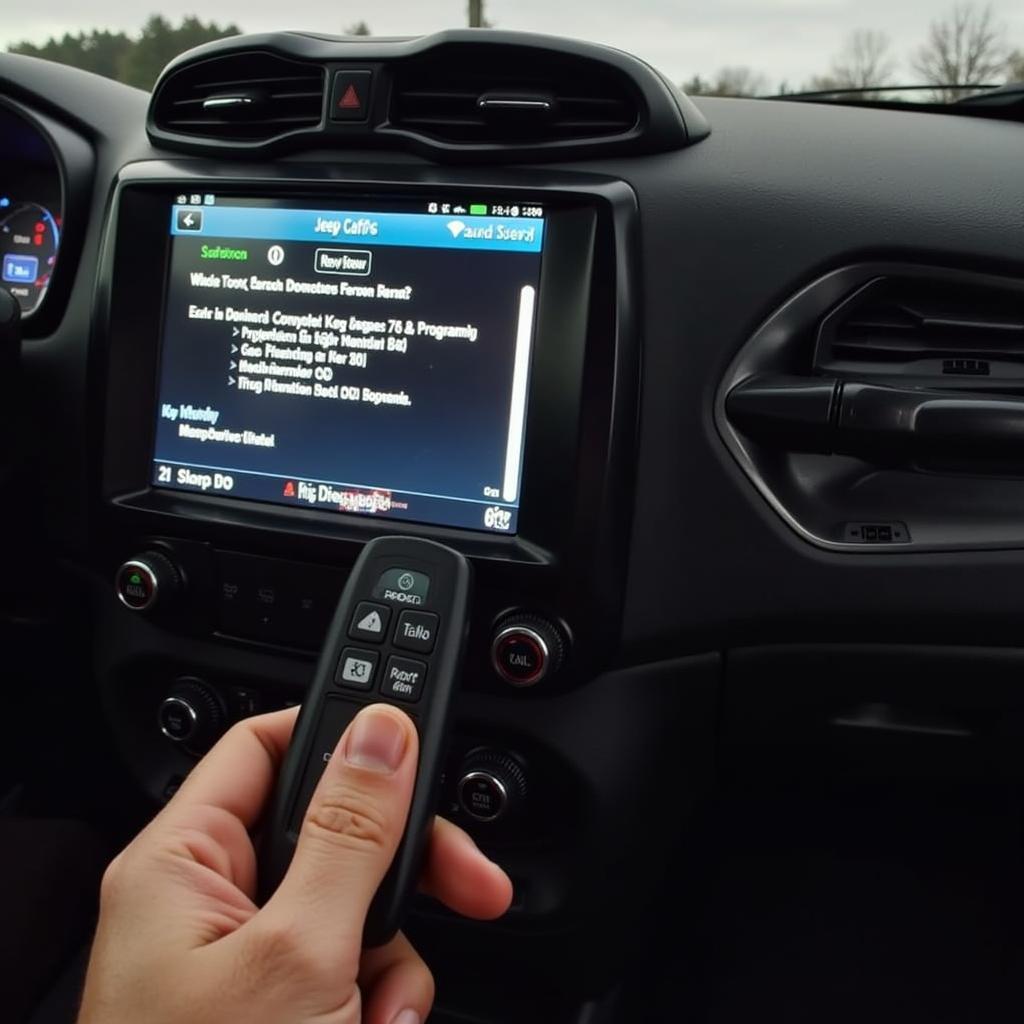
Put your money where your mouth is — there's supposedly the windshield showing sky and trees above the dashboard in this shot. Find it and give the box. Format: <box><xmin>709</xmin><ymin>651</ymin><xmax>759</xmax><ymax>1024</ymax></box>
<box><xmin>6</xmin><ymin>0</ymin><xmax>1024</xmax><ymax>102</ymax></box>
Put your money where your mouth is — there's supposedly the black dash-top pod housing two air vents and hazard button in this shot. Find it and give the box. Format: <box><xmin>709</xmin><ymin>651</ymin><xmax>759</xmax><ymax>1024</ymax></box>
<box><xmin>146</xmin><ymin>29</ymin><xmax>710</xmax><ymax>157</ymax></box>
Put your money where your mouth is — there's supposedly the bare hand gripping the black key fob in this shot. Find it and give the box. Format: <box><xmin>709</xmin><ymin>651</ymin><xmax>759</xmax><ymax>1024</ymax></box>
<box><xmin>79</xmin><ymin>705</ymin><xmax>512</xmax><ymax>1024</ymax></box>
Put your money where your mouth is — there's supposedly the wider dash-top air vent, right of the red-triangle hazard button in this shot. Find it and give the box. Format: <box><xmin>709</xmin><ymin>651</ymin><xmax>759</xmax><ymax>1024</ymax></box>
<box><xmin>390</xmin><ymin>44</ymin><xmax>643</xmax><ymax>145</ymax></box>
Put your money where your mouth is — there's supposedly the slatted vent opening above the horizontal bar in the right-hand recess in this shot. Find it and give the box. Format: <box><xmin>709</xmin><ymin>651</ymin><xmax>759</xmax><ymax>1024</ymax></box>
<box><xmin>814</xmin><ymin>276</ymin><xmax>1024</xmax><ymax>386</ymax></box>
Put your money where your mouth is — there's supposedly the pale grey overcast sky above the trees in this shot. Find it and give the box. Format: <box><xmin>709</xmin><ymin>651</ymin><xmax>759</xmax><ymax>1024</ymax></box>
<box><xmin>6</xmin><ymin>0</ymin><xmax>1024</xmax><ymax>88</ymax></box>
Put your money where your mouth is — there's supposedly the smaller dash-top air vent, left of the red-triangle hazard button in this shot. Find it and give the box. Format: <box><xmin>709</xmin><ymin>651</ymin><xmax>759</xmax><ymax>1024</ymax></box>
<box><xmin>152</xmin><ymin>51</ymin><xmax>325</xmax><ymax>142</ymax></box>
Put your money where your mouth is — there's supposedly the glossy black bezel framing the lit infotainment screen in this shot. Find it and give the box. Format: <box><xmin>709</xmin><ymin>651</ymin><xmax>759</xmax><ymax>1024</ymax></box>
<box><xmin>97</xmin><ymin>169</ymin><xmax>632</xmax><ymax>564</ymax></box>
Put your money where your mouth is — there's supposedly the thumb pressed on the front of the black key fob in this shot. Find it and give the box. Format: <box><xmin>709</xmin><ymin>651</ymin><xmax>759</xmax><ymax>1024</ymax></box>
<box><xmin>254</xmin><ymin>705</ymin><xmax>419</xmax><ymax>966</ymax></box>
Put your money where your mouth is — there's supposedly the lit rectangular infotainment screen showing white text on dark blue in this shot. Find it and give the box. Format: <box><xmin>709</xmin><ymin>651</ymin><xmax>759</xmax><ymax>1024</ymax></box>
<box><xmin>153</xmin><ymin>194</ymin><xmax>546</xmax><ymax>534</ymax></box>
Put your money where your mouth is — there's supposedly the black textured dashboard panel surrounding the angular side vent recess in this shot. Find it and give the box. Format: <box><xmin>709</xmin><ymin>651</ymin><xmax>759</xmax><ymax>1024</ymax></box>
<box><xmin>605</xmin><ymin>99</ymin><xmax>1024</xmax><ymax>654</ymax></box>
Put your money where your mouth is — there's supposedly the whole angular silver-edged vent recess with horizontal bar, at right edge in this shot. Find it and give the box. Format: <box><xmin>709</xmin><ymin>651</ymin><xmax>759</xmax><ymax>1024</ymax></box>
<box><xmin>715</xmin><ymin>261</ymin><xmax>1024</xmax><ymax>557</ymax></box>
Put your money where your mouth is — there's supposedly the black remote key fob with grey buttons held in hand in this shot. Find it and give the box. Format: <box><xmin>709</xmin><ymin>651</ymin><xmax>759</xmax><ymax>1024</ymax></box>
<box><xmin>260</xmin><ymin>537</ymin><xmax>472</xmax><ymax>946</ymax></box>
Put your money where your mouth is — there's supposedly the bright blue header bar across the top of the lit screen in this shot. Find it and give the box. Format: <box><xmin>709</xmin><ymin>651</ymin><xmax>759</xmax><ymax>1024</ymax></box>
<box><xmin>171</xmin><ymin>206</ymin><xmax>544</xmax><ymax>253</ymax></box>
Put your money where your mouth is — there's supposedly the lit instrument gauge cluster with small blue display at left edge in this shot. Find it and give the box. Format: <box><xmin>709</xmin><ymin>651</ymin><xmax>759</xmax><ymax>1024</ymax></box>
<box><xmin>0</xmin><ymin>106</ymin><xmax>63</xmax><ymax>316</ymax></box>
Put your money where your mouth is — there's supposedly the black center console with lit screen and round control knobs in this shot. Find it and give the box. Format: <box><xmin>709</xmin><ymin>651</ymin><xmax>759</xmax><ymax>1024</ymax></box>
<box><xmin>93</xmin><ymin>159</ymin><xmax>647</xmax><ymax>991</ymax></box>
